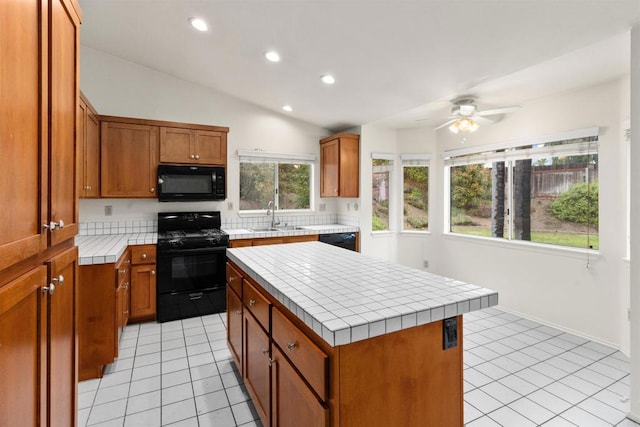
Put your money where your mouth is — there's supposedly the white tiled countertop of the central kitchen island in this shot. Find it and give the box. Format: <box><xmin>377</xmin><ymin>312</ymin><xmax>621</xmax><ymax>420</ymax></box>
<box><xmin>227</xmin><ymin>242</ymin><xmax>498</xmax><ymax>346</ymax></box>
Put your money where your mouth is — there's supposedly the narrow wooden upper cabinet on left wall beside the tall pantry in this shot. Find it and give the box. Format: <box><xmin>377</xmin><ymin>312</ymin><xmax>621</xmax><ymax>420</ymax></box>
<box><xmin>77</xmin><ymin>93</ymin><xmax>100</xmax><ymax>198</ymax></box>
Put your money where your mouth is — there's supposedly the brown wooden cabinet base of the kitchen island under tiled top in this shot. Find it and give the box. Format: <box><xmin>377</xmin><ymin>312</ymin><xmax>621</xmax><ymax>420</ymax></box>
<box><xmin>227</xmin><ymin>263</ymin><xmax>464</xmax><ymax>427</ymax></box>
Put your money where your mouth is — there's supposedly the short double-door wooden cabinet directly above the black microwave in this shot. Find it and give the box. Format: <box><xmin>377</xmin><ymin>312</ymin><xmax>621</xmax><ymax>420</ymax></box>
<box><xmin>160</xmin><ymin>126</ymin><xmax>228</xmax><ymax>165</ymax></box>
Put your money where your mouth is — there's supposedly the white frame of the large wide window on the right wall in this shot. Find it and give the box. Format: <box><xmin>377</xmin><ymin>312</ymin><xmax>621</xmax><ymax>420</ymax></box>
<box><xmin>442</xmin><ymin>127</ymin><xmax>600</xmax><ymax>254</ymax></box>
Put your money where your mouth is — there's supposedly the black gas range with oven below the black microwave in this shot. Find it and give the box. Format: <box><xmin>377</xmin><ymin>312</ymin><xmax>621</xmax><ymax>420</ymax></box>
<box><xmin>156</xmin><ymin>211</ymin><xmax>229</xmax><ymax>322</ymax></box>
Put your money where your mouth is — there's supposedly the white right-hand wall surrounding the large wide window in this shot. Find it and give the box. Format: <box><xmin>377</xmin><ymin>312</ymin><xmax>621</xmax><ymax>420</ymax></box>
<box><xmin>396</xmin><ymin>78</ymin><xmax>629</xmax><ymax>352</ymax></box>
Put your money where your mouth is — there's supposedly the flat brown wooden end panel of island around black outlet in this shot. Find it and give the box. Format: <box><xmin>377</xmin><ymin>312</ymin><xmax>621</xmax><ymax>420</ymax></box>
<box><xmin>339</xmin><ymin>316</ymin><xmax>463</xmax><ymax>427</ymax></box>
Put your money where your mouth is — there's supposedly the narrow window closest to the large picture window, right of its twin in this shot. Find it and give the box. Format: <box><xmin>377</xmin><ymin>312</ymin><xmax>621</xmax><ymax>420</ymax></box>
<box><xmin>401</xmin><ymin>154</ymin><xmax>429</xmax><ymax>231</ymax></box>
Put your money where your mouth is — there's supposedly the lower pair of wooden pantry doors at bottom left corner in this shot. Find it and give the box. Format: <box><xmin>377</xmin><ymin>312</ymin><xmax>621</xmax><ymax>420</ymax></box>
<box><xmin>0</xmin><ymin>247</ymin><xmax>78</xmax><ymax>426</ymax></box>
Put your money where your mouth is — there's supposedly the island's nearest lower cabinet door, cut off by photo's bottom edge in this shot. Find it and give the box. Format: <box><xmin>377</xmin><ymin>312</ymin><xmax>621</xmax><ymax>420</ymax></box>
<box><xmin>271</xmin><ymin>346</ymin><xmax>329</xmax><ymax>427</ymax></box>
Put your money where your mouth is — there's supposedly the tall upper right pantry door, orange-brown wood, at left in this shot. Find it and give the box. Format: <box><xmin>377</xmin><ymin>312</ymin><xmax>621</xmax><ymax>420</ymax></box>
<box><xmin>49</xmin><ymin>0</ymin><xmax>80</xmax><ymax>245</ymax></box>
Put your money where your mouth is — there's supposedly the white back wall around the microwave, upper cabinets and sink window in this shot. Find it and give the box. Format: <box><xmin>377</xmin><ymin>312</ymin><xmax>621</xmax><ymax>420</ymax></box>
<box><xmin>80</xmin><ymin>46</ymin><xmax>336</xmax><ymax>221</ymax></box>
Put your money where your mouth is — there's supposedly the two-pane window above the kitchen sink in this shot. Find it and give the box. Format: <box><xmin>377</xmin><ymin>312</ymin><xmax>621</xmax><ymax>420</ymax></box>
<box><xmin>239</xmin><ymin>151</ymin><xmax>315</xmax><ymax>211</ymax></box>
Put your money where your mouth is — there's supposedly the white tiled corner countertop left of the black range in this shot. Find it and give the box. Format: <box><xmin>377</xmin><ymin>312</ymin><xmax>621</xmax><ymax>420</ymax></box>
<box><xmin>75</xmin><ymin>233</ymin><xmax>158</xmax><ymax>265</ymax></box>
